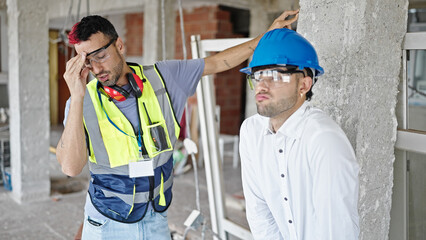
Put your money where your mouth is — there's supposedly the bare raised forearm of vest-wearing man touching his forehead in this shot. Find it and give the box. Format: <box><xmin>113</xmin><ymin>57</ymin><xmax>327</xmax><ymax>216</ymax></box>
<box><xmin>56</xmin><ymin>98</ymin><xmax>87</xmax><ymax>176</ymax></box>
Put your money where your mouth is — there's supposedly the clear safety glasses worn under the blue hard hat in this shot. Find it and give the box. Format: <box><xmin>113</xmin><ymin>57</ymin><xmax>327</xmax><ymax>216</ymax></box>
<box><xmin>247</xmin><ymin>69</ymin><xmax>305</xmax><ymax>89</ymax></box>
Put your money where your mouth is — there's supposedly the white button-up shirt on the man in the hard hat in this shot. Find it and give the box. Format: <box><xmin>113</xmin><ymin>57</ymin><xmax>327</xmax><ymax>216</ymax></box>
<box><xmin>240</xmin><ymin>103</ymin><xmax>359</xmax><ymax>240</ymax></box>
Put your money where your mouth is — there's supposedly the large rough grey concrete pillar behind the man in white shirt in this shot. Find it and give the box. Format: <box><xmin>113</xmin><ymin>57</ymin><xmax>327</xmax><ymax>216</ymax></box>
<box><xmin>298</xmin><ymin>0</ymin><xmax>408</xmax><ymax>239</ymax></box>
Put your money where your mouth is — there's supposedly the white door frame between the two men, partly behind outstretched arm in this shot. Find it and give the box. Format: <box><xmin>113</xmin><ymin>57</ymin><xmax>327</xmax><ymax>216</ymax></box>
<box><xmin>191</xmin><ymin>35</ymin><xmax>253</xmax><ymax>240</ymax></box>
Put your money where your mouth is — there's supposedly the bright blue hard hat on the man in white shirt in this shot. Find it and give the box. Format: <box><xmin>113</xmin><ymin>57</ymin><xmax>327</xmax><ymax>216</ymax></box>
<box><xmin>240</xmin><ymin>28</ymin><xmax>324</xmax><ymax>76</ymax></box>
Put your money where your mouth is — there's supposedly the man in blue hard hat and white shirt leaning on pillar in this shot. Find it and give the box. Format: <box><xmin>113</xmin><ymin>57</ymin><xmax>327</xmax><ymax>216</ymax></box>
<box><xmin>240</xmin><ymin>29</ymin><xmax>359</xmax><ymax>240</ymax></box>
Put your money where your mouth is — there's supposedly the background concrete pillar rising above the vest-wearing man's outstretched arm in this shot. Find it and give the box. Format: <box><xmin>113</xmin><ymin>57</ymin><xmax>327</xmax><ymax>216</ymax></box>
<box><xmin>143</xmin><ymin>0</ymin><xmax>176</xmax><ymax>64</ymax></box>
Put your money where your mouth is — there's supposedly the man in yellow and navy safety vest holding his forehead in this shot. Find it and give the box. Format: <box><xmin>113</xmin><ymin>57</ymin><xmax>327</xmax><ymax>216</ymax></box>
<box><xmin>57</xmin><ymin>11</ymin><xmax>298</xmax><ymax>240</ymax></box>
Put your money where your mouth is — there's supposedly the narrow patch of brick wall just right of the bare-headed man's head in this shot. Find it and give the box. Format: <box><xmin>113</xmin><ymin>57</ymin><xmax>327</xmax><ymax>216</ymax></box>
<box><xmin>125</xmin><ymin>13</ymin><xmax>143</xmax><ymax>56</ymax></box>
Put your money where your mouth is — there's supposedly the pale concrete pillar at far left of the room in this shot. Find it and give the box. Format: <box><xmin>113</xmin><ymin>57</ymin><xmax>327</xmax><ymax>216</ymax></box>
<box><xmin>7</xmin><ymin>0</ymin><xmax>50</xmax><ymax>203</ymax></box>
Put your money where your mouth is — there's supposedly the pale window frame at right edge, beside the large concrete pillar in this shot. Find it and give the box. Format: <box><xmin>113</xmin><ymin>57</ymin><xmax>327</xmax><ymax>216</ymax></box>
<box><xmin>389</xmin><ymin>32</ymin><xmax>426</xmax><ymax>240</ymax></box>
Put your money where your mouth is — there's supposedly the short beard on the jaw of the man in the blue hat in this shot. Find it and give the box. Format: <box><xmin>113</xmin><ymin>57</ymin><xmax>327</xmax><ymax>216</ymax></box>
<box><xmin>256</xmin><ymin>89</ymin><xmax>297</xmax><ymax>118</ymax></box>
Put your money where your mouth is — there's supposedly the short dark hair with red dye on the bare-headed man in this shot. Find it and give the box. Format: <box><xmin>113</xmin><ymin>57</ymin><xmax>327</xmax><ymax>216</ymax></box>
<box><xmin>68</xmin><ymin>15</ymin><xmax>118</xmax><ymax>44</ymax></box>
